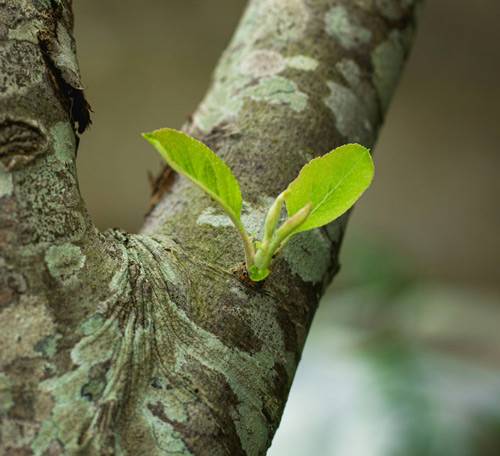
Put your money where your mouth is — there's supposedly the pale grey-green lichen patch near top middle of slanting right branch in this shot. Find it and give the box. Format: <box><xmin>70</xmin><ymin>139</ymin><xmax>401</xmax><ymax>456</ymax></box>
<box><xmin>325</xmin><ymin>5</ymin><xmax>372</xmax><ymax>50</ymax></box>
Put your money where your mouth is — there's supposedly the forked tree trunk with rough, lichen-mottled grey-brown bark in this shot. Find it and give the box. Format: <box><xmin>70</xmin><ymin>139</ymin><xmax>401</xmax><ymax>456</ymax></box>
<box><xmin>0</xmin><ymin>0</ymin><xmax>418</xmax><ymax>455</ymax></box>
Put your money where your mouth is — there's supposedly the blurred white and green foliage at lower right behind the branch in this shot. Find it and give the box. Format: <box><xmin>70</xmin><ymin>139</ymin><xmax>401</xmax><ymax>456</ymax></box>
<box><xmin>268</xmin><ymin>239</ymin><xmax>500</xmax><ymax>456</ymax></box>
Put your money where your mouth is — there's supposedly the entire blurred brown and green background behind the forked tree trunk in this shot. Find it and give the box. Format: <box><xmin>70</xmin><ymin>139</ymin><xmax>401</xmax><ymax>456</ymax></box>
<box><xmin>74</xmin><ymin>0</ymin><xmax>500</xmax><ymax>456</ymax></box>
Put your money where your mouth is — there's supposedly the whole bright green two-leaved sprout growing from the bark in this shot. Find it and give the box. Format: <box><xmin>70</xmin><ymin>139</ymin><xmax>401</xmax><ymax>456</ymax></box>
<box><xmin>143</xmin><ymin>128</ymin><xmax>374</xmax><ymax>282</ymax></box>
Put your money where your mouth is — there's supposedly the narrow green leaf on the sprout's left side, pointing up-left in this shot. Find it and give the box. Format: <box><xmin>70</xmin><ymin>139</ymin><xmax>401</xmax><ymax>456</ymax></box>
<box><xmin>143</xmin><ymin>128</ymin><xmax>242</xmax><ymax>228</ymax></box>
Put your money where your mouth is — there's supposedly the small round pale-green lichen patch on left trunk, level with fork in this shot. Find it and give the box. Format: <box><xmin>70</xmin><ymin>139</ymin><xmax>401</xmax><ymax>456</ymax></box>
<box><xmin>45</xmin><ymin>243</ymin><xmax>86</xmax><ymax>285</ymax></box>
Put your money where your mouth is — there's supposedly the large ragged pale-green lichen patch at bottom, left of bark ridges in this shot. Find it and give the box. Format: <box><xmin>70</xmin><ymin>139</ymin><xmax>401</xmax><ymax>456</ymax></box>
<box><xmin>32</xmin><ymin>319</ymin><xmax>125</xmax><ymax>455</ymax></box>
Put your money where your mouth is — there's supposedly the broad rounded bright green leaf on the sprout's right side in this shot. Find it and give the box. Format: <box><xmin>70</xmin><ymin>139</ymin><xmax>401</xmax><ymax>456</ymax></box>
<box><xmin>285</xmin><ymin>144</ymin><xmax>374</xmax><ymax>233</ymax></box>
